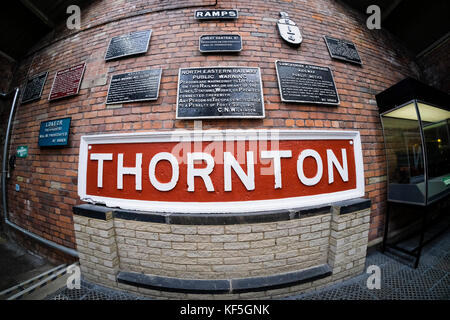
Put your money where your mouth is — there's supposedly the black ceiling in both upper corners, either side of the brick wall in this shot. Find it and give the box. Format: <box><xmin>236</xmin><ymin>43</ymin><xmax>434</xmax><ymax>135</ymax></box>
<box><xmin>0</xmin><ymin>0</ymin><xmax>450</xmax><ymax>60</ymax></box>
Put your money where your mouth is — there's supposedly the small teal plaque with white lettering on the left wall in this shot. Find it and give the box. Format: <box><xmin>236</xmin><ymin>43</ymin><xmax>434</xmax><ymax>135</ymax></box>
<box><xmin>38</xmin><ymin>118</ymin><xmax>71</xmax><ymax>147</ymax></box>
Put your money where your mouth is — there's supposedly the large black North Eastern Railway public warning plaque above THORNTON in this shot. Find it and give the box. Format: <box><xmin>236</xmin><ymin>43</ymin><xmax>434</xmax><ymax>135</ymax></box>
<box><xmin>177</xmin><ymin>67</ymin><xmax>264</xmax><ymax>119</ymax></box>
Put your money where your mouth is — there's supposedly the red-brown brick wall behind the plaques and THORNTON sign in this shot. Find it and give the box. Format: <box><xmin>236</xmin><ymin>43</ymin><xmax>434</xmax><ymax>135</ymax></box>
<box><xmin>8</xmin><ymin>0</ymin><xmax>424</xmax><ymax>260</ymax></box>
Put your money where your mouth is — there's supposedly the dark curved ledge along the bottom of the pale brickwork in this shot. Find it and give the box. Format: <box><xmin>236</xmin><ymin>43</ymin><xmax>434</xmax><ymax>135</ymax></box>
<box><xmin>117</xmin><ymin>264</ymin><xmax>332</xmax><ymax>294</ymax></box>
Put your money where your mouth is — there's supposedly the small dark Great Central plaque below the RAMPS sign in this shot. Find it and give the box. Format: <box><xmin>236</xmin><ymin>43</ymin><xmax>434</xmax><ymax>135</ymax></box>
<box><xmin>198</xmin><ymin>34</ymin><xmax>242</xmax><ymax>52</ymax></box>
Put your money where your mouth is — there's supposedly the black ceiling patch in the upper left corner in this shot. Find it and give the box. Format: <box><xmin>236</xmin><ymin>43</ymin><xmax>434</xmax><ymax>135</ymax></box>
<box><xmin>0</xmin><ymin>0</ymin><xmax>92</xmax><ymax>60</ymax></box>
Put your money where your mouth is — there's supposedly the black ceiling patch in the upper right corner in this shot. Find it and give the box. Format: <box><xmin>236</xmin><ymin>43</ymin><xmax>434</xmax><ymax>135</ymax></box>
<box><xmin>340</xmin><ymin>0</ymin><xmax>450</xmax><ymax>55</ymax></box>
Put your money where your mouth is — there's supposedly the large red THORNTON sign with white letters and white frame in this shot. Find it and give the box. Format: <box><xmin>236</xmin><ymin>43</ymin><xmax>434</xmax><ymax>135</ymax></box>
<box><xmin>78</xmin><ymin>130</ymin><xmax>364</xmax><ymax>213</ymax></box>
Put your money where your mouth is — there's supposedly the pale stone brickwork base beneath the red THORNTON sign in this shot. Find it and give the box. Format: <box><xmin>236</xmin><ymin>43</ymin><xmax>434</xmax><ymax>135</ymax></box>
<box><xmin>74</xmin><ymin>207</ymin><xmax>370</xmax><ymax>299</ymax></box>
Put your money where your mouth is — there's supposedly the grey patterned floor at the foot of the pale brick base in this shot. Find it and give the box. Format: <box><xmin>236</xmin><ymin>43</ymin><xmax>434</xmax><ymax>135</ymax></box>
<box><xmin>47</xmin><ymin>231</ymin><xmax>450</xmax><ymax>300</ymax></box>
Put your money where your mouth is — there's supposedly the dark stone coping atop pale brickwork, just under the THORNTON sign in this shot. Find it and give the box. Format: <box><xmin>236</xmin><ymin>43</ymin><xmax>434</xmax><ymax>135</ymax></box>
<box><xmin>73</xmin><ymin>198</ymin><xmax>371</xmax><ymax>225</ymax></box>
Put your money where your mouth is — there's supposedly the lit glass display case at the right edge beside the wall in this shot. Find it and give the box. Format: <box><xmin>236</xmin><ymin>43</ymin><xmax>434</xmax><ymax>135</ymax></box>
<box><xmin>380</xmin><ymin>100</ymin><xmax>450</xmax><ymax>206</ymax></box>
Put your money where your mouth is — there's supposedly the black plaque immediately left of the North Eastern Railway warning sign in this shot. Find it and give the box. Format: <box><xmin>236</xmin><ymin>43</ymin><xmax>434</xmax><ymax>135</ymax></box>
<box><xmin>106</xmin><ymin>69</ymin><xmax>162</xmax><ymax>104</ymax></box>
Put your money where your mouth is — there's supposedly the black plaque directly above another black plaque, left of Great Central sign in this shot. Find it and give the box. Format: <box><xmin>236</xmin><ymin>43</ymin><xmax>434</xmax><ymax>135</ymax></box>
<box><xmin>105</xmin><ymin>30</ymin><xmax>152</xmax><ymax>60</ymax></box>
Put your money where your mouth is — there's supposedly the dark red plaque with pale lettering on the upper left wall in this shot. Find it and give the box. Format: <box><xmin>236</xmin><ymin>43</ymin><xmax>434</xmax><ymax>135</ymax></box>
<box><xmin>48</xmin><ymin>62</ymin><xmax>86</xmax><ymax>100</ymax></box>
